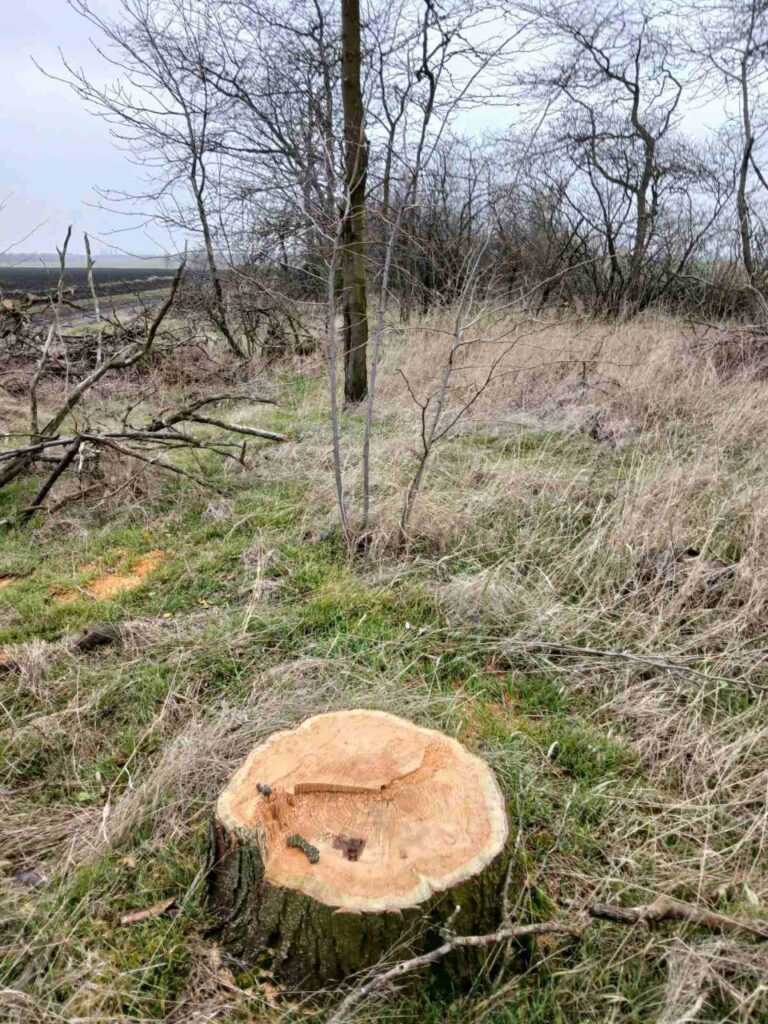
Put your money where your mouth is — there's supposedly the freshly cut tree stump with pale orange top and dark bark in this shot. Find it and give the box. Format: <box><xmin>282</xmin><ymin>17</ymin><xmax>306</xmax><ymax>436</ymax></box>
<box><xmin>208</xmin><ymin>711</ymin><xmax>514</xmax><ymax>990</ymax></box>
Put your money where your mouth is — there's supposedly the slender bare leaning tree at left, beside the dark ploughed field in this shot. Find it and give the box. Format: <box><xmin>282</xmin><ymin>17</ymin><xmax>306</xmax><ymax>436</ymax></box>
<box><xmin>56</xmin><ymin>0</ymin><xmax>244</xmax><ymax>355</ymax></box>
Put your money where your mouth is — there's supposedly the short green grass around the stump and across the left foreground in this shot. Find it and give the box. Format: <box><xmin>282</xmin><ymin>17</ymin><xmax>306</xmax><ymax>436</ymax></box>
<box><xmin>0</xmin><ymin>378</ymin><xmax>768</xmax><ymax>1024</ymax></box>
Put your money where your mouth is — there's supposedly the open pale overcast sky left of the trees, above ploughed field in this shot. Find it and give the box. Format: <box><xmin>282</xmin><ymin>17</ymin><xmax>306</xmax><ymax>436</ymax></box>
<box><xmin>0</xmin><ymin>0</ymin><xmax>176</xmax><ymax>253</ymax></box>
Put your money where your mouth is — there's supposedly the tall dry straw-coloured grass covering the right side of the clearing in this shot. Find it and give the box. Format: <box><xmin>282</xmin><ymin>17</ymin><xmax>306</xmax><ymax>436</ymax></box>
<box><xmin>362</xmin><ymin>307</ymin><xmax>768</xmax><ymax>1021</ymax></box>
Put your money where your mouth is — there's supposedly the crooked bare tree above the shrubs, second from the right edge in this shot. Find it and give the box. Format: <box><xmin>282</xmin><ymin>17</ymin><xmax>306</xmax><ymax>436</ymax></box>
<box><xmin>520</xmin><ymin>0</ymin><xmax>683</xmax><ymax>309</ymax></box>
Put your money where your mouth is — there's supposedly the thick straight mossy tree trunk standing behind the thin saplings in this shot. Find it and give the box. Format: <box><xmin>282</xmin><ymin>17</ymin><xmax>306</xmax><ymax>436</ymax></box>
<box><xmin>341</xmin><ymin>0</ymin><xmax>368</xmax><ymax>404</ymax></box>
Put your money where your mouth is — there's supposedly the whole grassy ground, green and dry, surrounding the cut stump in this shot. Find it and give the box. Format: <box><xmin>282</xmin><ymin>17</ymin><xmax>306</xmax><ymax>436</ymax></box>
<box><xmin>0</xmin><ymin>316</ymin><xmax>768</xmax><ymax>1024</ymax></box>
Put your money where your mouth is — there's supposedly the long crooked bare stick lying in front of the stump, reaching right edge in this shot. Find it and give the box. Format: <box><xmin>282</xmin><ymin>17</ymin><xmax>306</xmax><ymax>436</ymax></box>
<box><xmin>327</xmin><ymin>896</ymin><xmax>768</xmax><ymax>1024</ymax></box>
